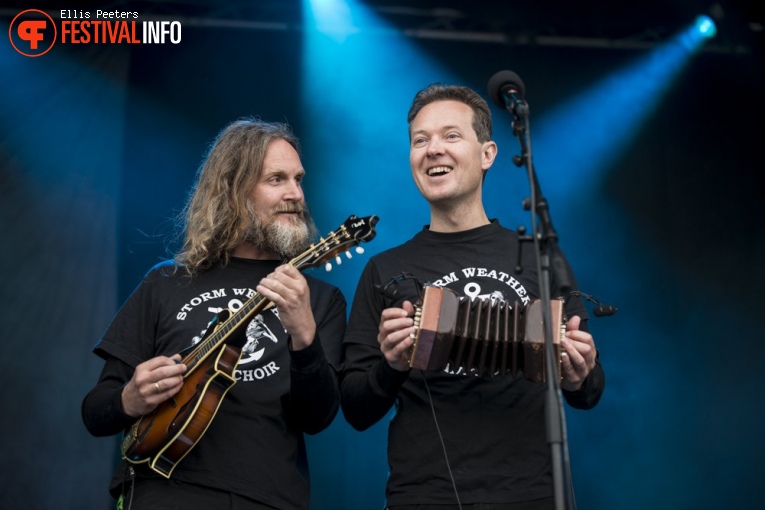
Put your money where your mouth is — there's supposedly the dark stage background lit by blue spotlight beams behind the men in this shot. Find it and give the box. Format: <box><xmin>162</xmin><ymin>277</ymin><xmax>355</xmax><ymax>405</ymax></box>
<box><xmin>0</xmin><ymin>1</ymin><xmax>765</xmax><ymax>510</ymax></box>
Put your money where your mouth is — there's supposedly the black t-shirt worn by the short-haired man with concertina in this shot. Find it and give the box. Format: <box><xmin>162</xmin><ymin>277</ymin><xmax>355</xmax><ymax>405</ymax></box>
<box><xmin>341</xmin><ymin>221</ymin><xmax>604</xmax><ymax>506</ymax></box>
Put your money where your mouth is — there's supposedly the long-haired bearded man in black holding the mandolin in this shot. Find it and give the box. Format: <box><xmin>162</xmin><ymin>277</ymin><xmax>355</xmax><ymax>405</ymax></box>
<box><xmin>82</xmin><ymin>118</ymin><xmax>346</xmax><ymax>510</ymax></box>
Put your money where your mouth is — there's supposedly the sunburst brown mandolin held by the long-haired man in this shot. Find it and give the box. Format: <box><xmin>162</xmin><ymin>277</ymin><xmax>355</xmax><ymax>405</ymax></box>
<box><xmin>121</xmin><ymin>216</ymin><xmax>378</xmax><ymax>478</ymax></box>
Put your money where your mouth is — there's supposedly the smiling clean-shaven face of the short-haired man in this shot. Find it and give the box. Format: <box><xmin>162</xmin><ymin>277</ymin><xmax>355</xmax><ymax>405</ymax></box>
<box><xmin>409</xmin><ymin>100</ymin><xmax>497</xmax><ymax>210</ymax></box>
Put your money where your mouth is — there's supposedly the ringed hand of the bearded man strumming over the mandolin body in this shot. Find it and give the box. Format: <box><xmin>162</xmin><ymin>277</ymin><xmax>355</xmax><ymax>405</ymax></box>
<box><xmin>122</xmin><ymin>354</ymin><xmax>186</xmax><ymax>418</ymax></box>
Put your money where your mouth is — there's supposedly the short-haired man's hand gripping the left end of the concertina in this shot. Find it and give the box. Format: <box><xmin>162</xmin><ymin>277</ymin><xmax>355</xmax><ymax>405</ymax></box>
<box><xmin>377</xmin><ymin>301</ymin><xmax>416</xmax><ymax>372</ymax></box>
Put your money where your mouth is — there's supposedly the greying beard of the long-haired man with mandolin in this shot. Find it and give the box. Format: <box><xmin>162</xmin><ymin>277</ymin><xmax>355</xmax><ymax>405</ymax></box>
<box><xmin>244</xmin><ymin>200</ymin><xmax>317</xmax><ymax>259</ymax></box>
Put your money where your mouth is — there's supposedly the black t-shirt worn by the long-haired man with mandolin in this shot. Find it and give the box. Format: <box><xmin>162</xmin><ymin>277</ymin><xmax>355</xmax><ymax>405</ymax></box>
<box><xmin>83</xmin><ymin>258</ymin><xmax>346</xmax><ymax>509</ymax></box>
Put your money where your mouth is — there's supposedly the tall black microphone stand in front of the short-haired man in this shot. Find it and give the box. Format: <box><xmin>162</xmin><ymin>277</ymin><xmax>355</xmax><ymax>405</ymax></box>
<box><xmin>505</xmin><ymin>98</ymin><xmax>576</xmax><ymax>510</ymax></box>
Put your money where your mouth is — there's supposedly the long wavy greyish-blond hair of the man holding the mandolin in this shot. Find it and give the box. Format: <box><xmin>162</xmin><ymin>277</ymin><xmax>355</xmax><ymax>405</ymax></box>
<box><xmin>174</xmin><ymin>117</ymin><xmax>300</xmax><ymax>276</ymax></box>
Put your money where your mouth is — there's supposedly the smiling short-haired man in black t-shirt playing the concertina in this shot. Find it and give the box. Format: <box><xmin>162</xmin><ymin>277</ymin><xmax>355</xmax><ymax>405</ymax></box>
<box><xmin>341</xmin><ymin>84</ymin><xmax>605</xmax><ymax>510</ymax></box>
